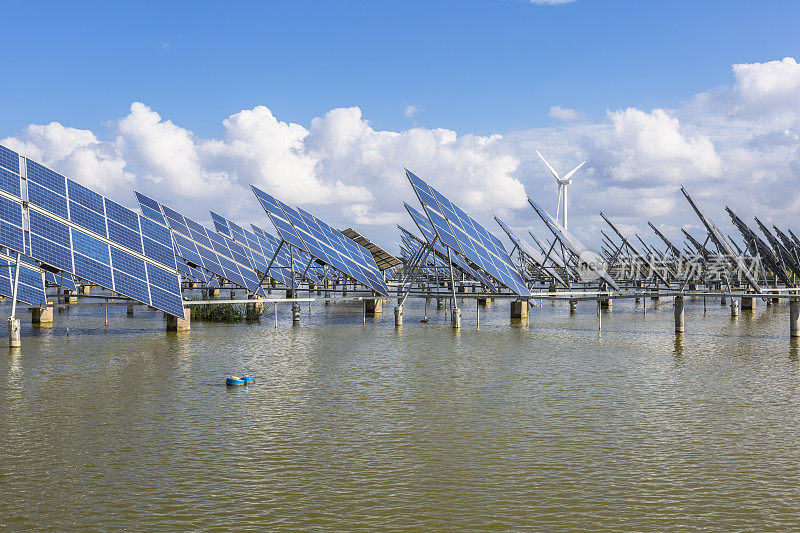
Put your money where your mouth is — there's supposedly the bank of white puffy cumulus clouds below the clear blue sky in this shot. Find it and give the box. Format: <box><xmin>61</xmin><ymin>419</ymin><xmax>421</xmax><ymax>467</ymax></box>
<box><xmin>2</xmin><ymin>58</ymin><xmax>800</xmax><ymax>251</ymax></box>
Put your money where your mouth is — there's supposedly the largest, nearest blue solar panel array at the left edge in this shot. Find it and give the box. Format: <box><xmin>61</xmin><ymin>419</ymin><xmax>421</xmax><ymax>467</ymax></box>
<box><xmin>0</xmin><ymin>147</ymin><xmax>183</xmax><ymax>316</ymax></box>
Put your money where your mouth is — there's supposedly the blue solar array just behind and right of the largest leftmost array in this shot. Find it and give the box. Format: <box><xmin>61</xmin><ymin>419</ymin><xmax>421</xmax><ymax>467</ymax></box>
<box><xmin>135</xmin><ymin>192</ymin><xmax>266</xmax><ymax>296</ymax></box>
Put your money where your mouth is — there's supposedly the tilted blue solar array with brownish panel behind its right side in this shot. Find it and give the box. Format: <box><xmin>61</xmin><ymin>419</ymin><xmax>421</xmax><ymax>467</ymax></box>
<box><xmin>251</xmin><ymin>186</ymin><xmax>389</xmax><ymax>296</ymax></box>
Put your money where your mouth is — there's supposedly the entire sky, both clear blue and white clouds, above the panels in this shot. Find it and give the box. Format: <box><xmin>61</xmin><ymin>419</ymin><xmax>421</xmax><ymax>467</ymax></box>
<box><xmin>0</xmin><ymin>0</ymin><xmax>800</xmax><ymax>249</ymax></box>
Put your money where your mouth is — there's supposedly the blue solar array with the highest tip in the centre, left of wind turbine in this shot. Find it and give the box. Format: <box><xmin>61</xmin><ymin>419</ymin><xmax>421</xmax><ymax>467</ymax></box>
<box><xmin>406</xmin><ymin>170</ymin><xmax>531</xmax><ymax>296</ymax></box>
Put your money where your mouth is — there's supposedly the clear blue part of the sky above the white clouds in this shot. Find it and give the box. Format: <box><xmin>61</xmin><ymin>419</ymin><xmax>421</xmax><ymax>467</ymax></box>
<box><xmin>2</xmin><ymin>0</ymin><xmax>800</xmax><ymax>136</ymax></box>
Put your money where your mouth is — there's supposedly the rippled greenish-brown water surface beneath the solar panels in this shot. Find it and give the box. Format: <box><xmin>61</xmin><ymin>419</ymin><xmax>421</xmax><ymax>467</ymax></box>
<box><xmin>0</xmin><ymin>299</ymin><xmax>800</xmax><ymax>530</ymax></box>
